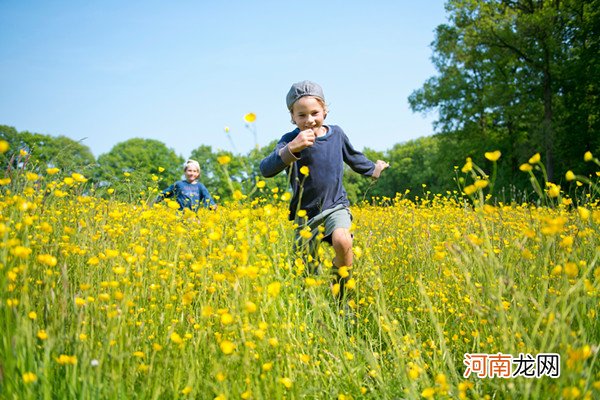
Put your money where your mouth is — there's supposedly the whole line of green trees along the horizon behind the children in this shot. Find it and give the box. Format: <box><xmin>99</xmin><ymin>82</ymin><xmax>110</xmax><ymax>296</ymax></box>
<box><xmin>0</xmin><ymin>0</ymin><xmax>600</xmax><ymax>202</ymax></box>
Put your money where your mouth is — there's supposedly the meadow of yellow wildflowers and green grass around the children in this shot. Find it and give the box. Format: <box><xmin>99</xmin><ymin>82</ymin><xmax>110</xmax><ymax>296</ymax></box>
<box><xmin>0</xmin><ymin>151</ymin><xmax>600</xmax><ymax>399</ymax></box>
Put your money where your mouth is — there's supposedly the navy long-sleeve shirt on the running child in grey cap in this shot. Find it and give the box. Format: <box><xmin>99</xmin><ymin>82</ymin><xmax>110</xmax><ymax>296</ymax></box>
<box><xmin>260</xmin><ymin>125</ymin><xmax>375</xmax><ymax>220</ymax></box>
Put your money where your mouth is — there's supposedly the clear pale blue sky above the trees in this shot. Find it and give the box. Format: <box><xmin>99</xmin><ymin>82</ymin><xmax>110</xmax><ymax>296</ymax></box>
<box><xmin>0</xmin><ymin>0</ymin><xmax>446</xmax><ymax>157</ymax></box>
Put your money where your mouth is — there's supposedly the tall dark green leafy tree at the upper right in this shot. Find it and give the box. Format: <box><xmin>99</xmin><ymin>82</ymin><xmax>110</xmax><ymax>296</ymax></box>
<box><xmin>409</xmin><ymin>0</ymin><xmax>600</xmax><ymax>185</ymax></box>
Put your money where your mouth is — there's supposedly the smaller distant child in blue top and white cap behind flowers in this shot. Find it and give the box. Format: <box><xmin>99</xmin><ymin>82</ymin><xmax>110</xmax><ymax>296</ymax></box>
<box><xmin>156</xmin><ymin>160</ymin><xmax>217</xmax><ymax>211</ymax></box>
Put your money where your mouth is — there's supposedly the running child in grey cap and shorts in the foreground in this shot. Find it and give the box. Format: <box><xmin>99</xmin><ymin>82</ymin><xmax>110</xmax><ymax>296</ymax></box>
<box><xmin>260</xmin><ymin>81</ymin><xmax>389</xmax><ymax>299</ymax></box>
